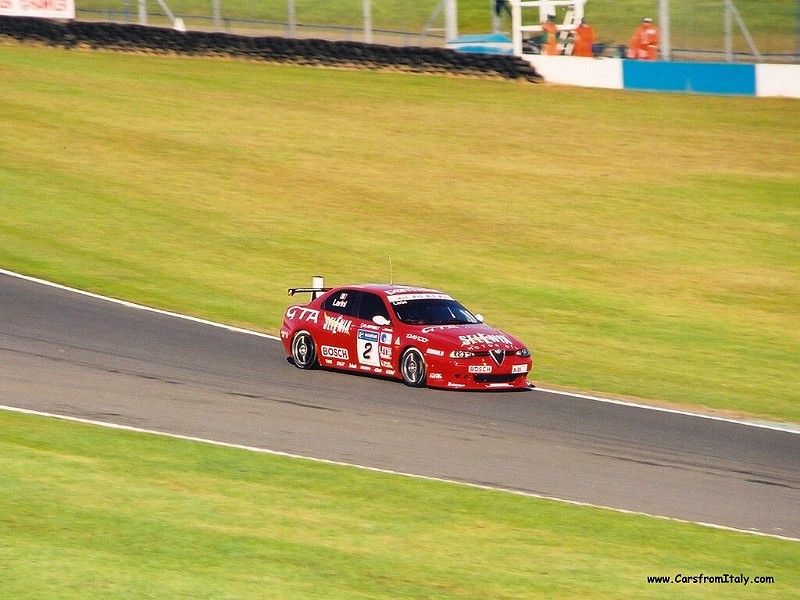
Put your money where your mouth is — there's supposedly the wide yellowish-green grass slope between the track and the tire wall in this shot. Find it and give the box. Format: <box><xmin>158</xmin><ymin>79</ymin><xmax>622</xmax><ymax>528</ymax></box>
<box><xmin>0</xmin><ymin>46</ymin><xmax>800</xmax><ymax>423</ymax></box>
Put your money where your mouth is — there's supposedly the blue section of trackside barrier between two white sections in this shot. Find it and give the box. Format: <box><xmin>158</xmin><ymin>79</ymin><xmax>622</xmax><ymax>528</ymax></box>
<box><xmin>622</xmin><ymin>60</ymin><xmax>756</xmax><ymax>96</ymax></box>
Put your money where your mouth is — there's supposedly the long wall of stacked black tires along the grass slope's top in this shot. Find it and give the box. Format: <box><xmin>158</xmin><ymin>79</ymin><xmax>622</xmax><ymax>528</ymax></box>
<box><xmin>0</xmin><ymin>16</ymin><xmax>541</xmax><ymax>81</ymax></box>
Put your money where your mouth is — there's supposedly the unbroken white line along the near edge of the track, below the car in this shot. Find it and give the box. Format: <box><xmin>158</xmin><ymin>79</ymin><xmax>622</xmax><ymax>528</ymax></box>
<box><xmin>0</xmin><ymin>404</ymin><xmax>800</xmax><ymax>542</ymax></box>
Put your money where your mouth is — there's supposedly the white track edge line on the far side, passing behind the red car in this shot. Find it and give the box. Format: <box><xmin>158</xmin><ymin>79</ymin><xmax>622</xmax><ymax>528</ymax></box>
<box><xmin>0</xmin><ymin>269</ymin><xmax>800</xmax><ymax>434</ymax></box>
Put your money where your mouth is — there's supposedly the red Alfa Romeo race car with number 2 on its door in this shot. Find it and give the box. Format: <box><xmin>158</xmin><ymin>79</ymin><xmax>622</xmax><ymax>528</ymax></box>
<box><xmin>281</xmin><ymin>284</ymin><xmax>532</xmax><ymax>390</ymax></box>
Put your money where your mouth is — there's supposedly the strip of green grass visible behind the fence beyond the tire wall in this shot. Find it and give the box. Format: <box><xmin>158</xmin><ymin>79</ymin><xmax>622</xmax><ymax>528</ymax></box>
<box><xmin>76</xmin><ymin>0</ymin><xmax>800</xmax><ymax>54</ymax></box>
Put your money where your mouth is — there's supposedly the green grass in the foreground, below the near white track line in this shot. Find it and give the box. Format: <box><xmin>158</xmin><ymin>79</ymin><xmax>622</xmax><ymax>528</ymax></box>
<box><xmin>0</xmin><ymin>411</ymin><xmax>800</xmax><ymax>600</ymax></box>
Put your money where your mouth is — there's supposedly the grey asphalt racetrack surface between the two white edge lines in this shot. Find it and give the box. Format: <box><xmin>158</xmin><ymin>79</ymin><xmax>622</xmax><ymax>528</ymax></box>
<box><xmin>0</xmin><ymin>272</ymin><xmax>800</xmax><ymax>539</ymax></box>
